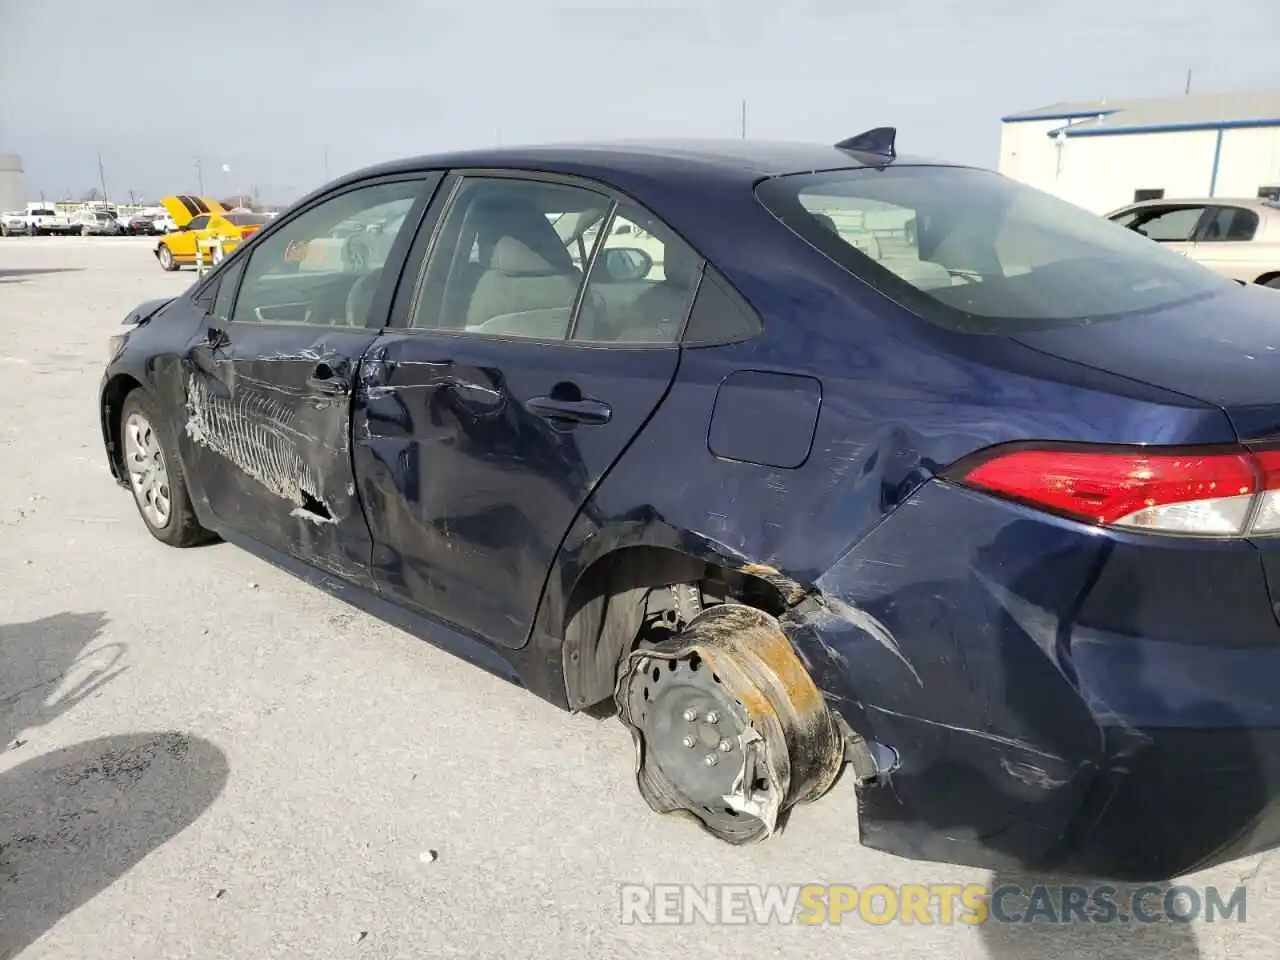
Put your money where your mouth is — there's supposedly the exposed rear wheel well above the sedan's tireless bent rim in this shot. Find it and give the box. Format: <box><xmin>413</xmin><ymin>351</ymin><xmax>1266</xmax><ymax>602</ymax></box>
<box><xmin>562</xmin><ymin>547</ymin><xmax>790</xmax><ymax>710</ymax></box>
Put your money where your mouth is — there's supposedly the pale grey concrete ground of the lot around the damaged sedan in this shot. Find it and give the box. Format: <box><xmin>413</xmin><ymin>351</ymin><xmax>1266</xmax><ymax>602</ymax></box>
<box><xmin>0</xmin><ymin>238</ymin><xmax>1280</xmax><ymax>960</ymax></box>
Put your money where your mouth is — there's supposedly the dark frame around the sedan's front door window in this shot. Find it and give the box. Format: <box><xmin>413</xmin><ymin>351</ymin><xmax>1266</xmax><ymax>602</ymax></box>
<box><xmin>217</xmin><ymin>168</ymin><xmax>445</xmax><ymax>330</ymax></box>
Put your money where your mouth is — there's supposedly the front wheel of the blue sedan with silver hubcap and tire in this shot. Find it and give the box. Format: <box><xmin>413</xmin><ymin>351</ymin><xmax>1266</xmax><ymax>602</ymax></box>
<box><xmin>120</xmin><ymin>389</ymin><xmax>209</xmax><ymax>547</ymax></box>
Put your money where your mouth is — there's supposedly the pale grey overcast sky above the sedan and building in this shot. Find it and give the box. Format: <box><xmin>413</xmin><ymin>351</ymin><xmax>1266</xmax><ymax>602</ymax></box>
<box><xmin>0</xmin><ymin>0</ymin><xmax>1280</xmax><ymax>201</ymax></box>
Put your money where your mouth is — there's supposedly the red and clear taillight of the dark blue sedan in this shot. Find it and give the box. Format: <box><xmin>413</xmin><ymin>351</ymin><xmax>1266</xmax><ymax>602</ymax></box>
<box><xmin>954</xmin><ymin>447</ymin><xmax>1280</xmax><ymax>536</ymax></box>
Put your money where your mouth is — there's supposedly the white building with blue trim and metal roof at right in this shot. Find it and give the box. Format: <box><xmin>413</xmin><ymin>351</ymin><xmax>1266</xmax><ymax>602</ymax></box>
<box><xmin>1000</xmin><ymin>91</ymin><xmax>1280</xmax><ymax>214</ymax></box>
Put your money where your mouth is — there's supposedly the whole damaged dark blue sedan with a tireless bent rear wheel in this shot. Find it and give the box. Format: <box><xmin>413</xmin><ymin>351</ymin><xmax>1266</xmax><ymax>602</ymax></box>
<box><xmin>100</xmin><ymin>129</ymin><xmax>1280</xmax><ymax>878</ymax></box>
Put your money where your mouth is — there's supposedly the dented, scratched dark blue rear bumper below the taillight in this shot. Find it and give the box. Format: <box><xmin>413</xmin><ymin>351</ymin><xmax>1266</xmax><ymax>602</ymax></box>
<box><xmin>790</xmin><ymin>483</ymin><xmax>1280</xmax><ymax>879</ymax></box>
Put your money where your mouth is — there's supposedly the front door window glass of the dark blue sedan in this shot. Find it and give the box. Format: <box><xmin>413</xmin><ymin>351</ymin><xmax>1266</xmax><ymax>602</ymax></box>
<box><xmin>232</xmin><ymin>180</ymin><xmax>424</xmax><ymax>326</ymax></box>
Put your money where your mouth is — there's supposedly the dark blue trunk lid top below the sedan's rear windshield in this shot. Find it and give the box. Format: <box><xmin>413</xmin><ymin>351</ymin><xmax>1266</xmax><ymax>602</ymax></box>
<box><xmin>1012</xmin><ymin>285</ymin><xmax>1280</xmax><ymax>440</ymax></box>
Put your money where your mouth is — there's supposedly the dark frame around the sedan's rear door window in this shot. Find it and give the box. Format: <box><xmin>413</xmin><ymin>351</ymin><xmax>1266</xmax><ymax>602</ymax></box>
<box><xmin>387</xmin><ymin>166</ymin><xmax>712</xmax><ymax>351</ymax></box>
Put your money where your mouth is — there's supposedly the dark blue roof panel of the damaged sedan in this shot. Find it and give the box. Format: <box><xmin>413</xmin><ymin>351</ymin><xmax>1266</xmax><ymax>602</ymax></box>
<box><xmin>330</xmin><ymin>140</ymin><xmax>940</xmax><ymax>190</ymax></box>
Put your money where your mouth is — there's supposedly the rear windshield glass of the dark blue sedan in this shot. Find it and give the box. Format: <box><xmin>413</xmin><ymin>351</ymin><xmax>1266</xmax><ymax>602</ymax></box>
<box><xmin>758</xmin><ymin>166</ymin><xmax>1231</xmax><ymax>334</ymax></box>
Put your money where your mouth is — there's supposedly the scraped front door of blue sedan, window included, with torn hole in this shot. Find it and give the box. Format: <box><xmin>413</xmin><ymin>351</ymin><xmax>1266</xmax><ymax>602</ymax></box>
<box><xmin>182</xmin><ymin>177</ymin><xmax>438</xmax><ymax>586</ymax></box>
